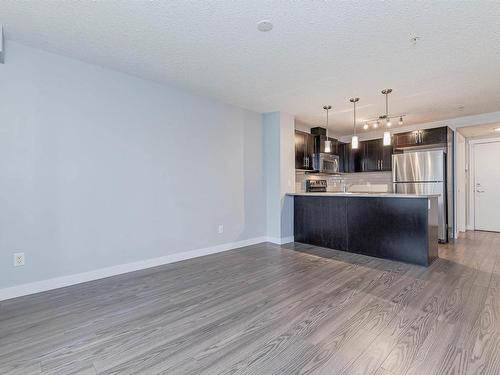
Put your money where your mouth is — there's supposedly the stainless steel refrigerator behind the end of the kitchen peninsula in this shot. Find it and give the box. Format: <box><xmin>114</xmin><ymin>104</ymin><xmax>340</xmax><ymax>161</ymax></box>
<box><xmin>392</xmin><ymin>149</ymin><xmax>449</xmax><ymax>242</ymax></box>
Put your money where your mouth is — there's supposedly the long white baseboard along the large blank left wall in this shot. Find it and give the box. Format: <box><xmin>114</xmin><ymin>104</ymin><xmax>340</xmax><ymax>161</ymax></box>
<box><xmin>0</xmin><ymin>237</ymin><xmax>268</xmax><ymax>301</ymax></box>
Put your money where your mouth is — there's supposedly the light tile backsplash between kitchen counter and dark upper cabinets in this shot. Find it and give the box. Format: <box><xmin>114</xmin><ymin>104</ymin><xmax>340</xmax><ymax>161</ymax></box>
<box><xmin>295</xmin><ymin>171</ymin><xmax>392</xmax><ymax>193</ymax></box>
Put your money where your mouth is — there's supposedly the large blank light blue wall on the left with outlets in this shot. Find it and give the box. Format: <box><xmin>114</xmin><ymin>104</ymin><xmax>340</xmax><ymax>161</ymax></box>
<box><xmin>0</xmin><ymin>42</ymin><xmax>266</xmax><ymax>288</ymax></box>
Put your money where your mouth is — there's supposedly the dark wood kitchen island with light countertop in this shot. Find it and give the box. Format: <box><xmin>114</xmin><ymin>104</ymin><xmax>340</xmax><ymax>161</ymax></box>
<box><xmin>288</xmin><ymin>193</ymin><xmax>438</xmax><ymax>266</ymax></box>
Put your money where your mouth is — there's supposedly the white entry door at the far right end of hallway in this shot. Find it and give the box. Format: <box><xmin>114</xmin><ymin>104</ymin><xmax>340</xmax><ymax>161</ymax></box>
<box><xmin>474</xmin><ymin>142</ymin><xmax>500</xmax><ymax>232</ymax></box>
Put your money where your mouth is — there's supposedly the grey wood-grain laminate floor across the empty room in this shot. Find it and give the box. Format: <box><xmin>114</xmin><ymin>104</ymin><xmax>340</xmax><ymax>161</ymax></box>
<box><xmin>0</xmin><ymin>232</ymin><xmax>500</xmax><ymax>375</ymax></box>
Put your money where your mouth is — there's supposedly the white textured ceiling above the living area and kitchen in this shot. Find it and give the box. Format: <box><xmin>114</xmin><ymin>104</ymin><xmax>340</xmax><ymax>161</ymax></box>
<box><xmin>0</xmin><ymin>0</ymin><xmax>500</xmax><ymax>134</ymax></box>
